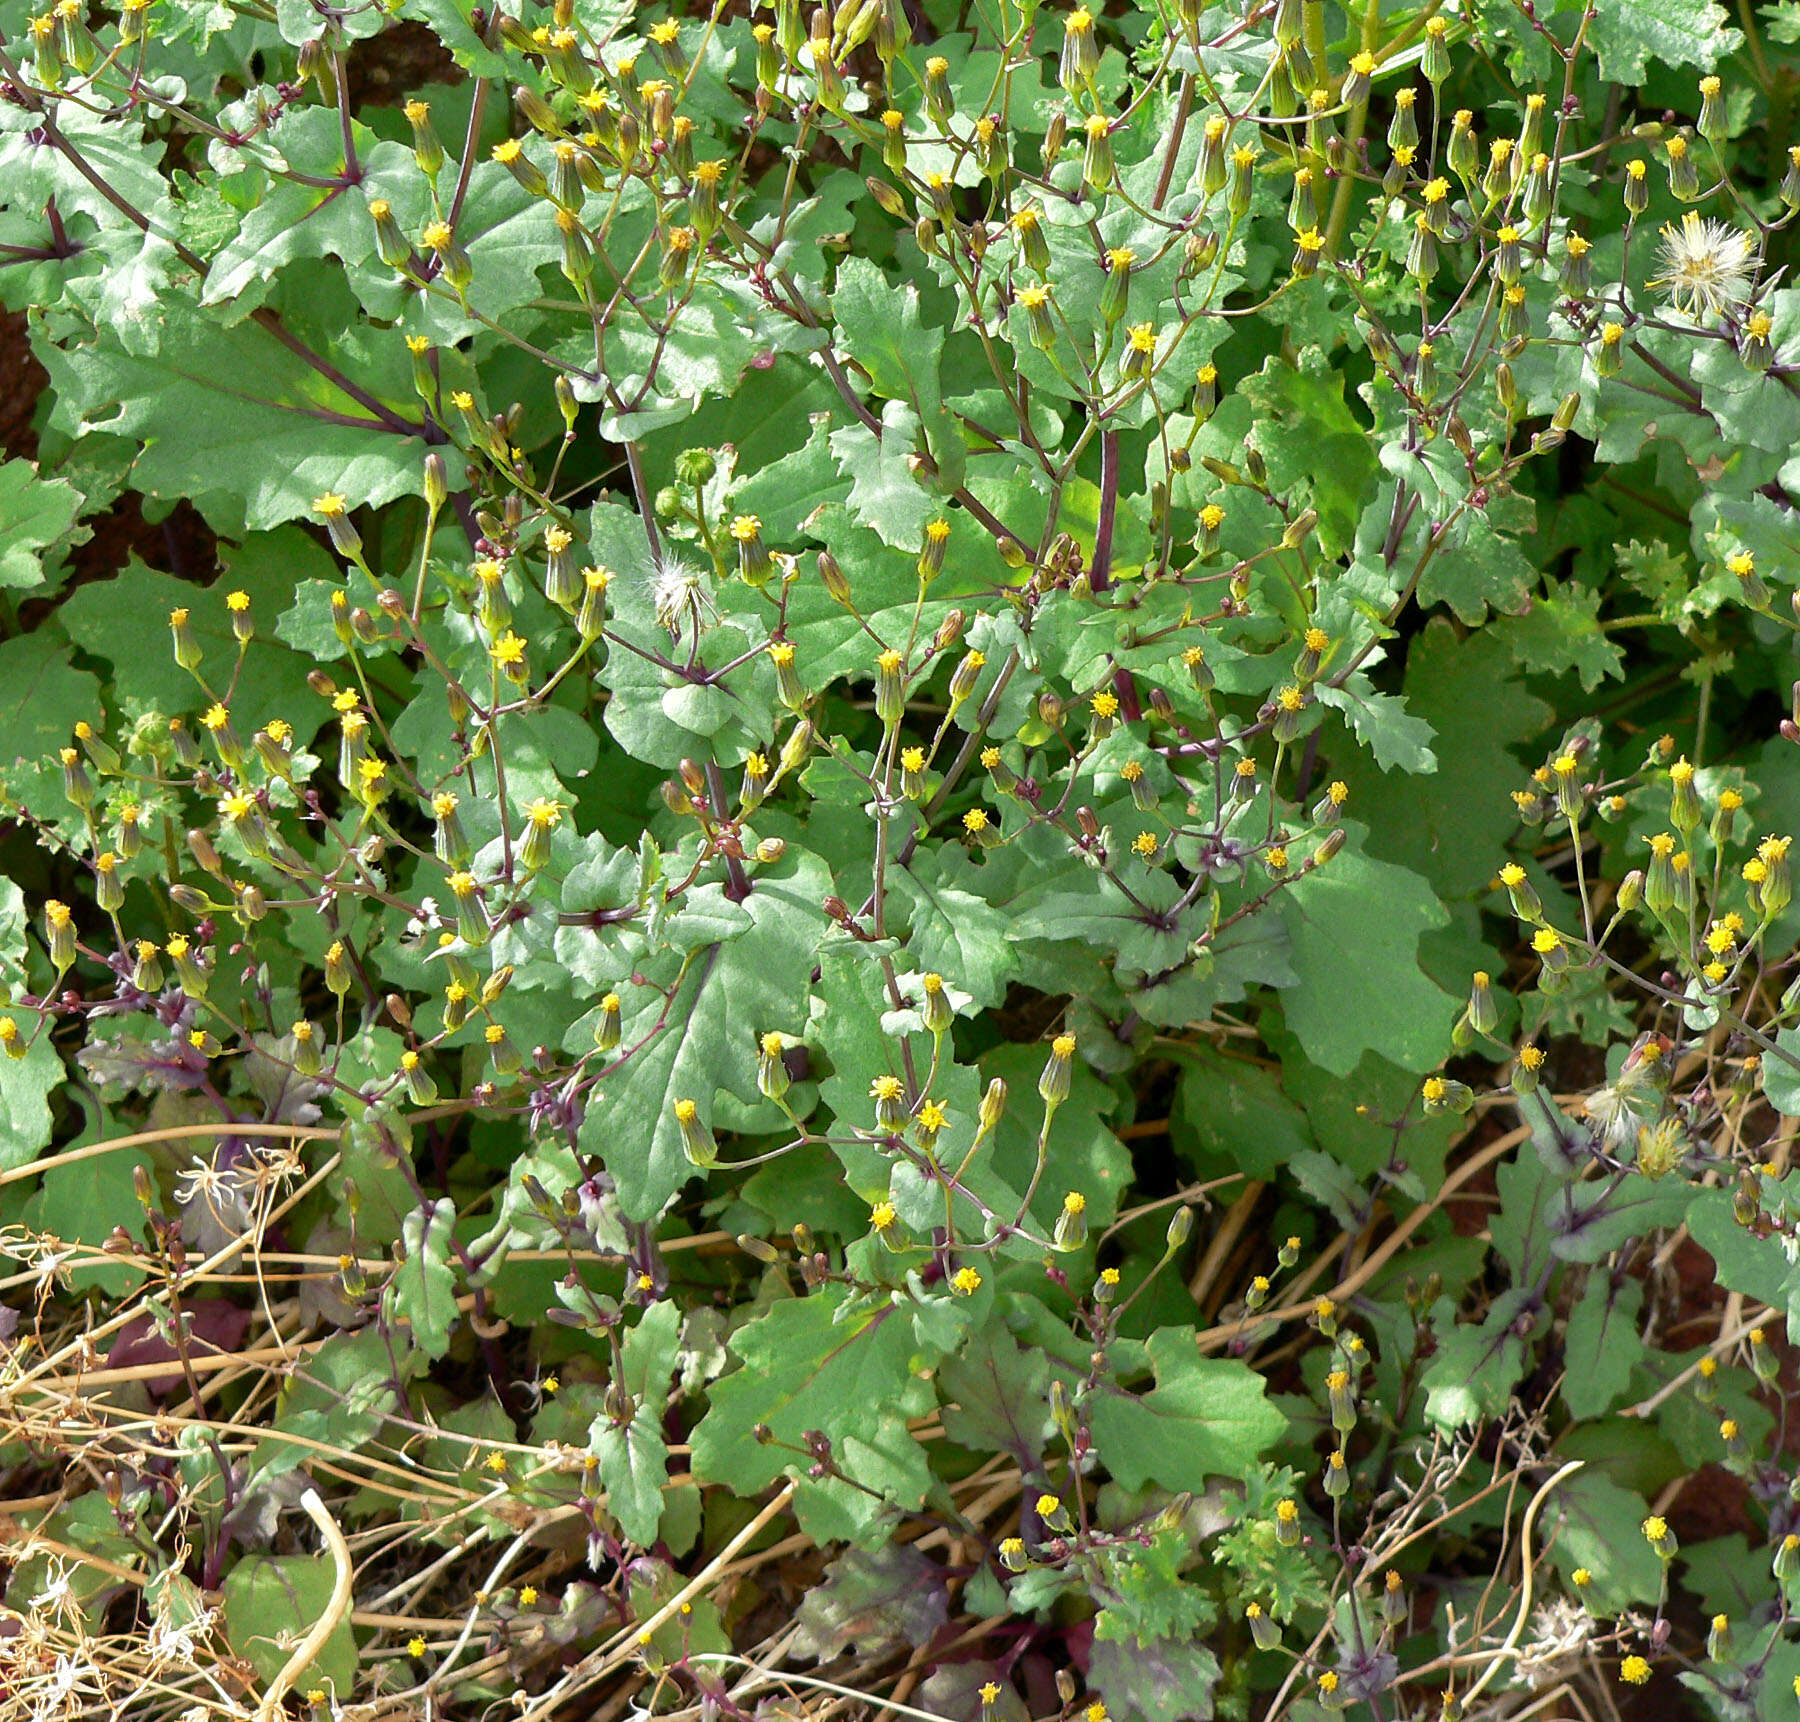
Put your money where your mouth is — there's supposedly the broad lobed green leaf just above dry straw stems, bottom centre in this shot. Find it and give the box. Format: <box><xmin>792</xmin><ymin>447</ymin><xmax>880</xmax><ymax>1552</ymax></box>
<box><xmin>691</xmin><ymin>1287</ymin><xmax>934</xmax><ymax>1506</ymax></box>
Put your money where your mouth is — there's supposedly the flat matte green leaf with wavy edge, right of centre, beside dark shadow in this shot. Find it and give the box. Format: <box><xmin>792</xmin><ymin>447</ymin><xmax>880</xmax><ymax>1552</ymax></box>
<box><xmin>1278</xmin><ymin>822</ymin><xmax>1462</xmax><ymax>1076</ymax></box>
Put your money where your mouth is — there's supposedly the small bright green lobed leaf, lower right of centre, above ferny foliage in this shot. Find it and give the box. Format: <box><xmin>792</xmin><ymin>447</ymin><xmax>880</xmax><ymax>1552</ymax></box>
<box><xmin>1089</xmin><ymin>1328</ymin><xmax>1287</xmax><ymax>1493</ymax></box>
